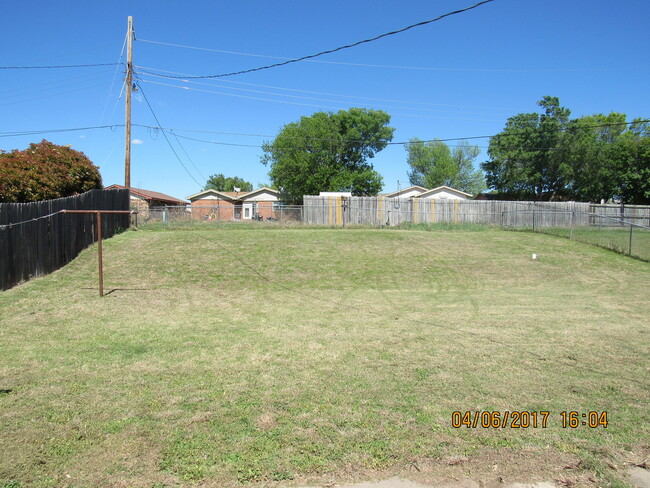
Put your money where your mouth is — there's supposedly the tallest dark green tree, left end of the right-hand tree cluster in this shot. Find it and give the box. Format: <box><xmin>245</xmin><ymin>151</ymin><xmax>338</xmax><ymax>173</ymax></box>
<box><xmin>481</xmin><ymin>96</ymin><xmax>573</xmax><ymax>200</ymax></box>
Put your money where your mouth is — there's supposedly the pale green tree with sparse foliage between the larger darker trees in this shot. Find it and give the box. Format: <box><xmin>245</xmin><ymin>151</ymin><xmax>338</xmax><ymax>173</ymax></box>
<box><xmin>406</xmin><ymin>138</ymin><xmax>487</xmax><ymax>195</ymax></box>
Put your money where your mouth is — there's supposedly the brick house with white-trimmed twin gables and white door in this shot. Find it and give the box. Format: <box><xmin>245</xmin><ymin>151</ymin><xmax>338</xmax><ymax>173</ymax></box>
<box><xmin>187</xmin><ymin>187</ymin><xmax>280</xmax><ymax>220</ymax></box>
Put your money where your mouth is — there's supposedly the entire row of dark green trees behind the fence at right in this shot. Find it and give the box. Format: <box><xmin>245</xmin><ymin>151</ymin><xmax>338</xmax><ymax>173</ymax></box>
<box><xmin>481</xmin><ymin>96</ymin><xmax>650</xmax><ymax>204</ymax></box>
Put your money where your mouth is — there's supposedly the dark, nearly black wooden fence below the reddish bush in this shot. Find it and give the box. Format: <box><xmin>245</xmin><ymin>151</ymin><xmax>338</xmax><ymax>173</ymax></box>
<box><xmin>0</xmin><ymin>189</ymin><xmax>130</xmax><ymax>290</ymax></box>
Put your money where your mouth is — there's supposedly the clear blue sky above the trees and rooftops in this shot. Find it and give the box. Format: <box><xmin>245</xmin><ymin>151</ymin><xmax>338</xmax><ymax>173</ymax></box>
<box><xmin>0</xmin><ymin>0</ymin><xmax>650</xmax><ymax>198</ymax></box>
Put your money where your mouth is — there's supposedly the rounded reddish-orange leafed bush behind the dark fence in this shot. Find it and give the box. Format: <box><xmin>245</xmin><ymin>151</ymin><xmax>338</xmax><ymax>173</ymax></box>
<box><xmin>0</xmin><ymin>139</ymin><xmax>102</xmax><ymax>202</ymax></box>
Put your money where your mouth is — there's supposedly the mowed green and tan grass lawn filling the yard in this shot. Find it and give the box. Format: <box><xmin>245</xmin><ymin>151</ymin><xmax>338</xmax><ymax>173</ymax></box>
<box><xmin>0</xmin><ymin>225</ymin><xmax>650</xmax><ymax>488</ymax></box>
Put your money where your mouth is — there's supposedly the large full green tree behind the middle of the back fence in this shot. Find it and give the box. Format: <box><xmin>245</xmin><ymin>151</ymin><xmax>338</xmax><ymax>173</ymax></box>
<box><xmin>262</xmin><ymin>108</ymin><xmax>395</xmax><ymax>203</ymax></box>
